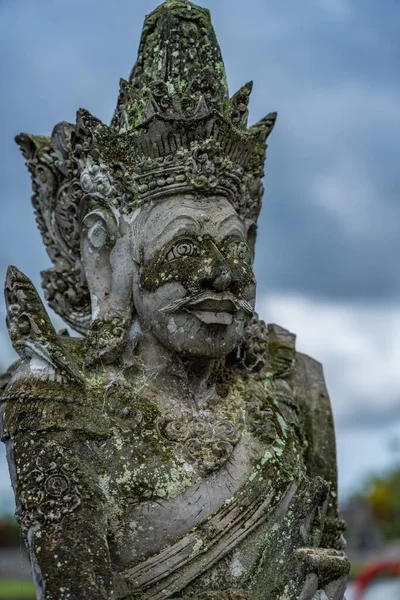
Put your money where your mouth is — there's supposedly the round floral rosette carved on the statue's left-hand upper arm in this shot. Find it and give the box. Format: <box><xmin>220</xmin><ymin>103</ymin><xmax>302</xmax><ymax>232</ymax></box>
<box><xmin>16</xmin><ymin>445</ymin><xmax>88</xmax><ymax>529</ymax></box>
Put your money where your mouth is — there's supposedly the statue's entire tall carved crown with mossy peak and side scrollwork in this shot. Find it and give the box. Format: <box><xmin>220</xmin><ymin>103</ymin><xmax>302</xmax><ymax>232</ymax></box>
<box><xmin>16</xmin><ymin>0</ymin><xmax>276</xmax><ymax>333</ymax></box>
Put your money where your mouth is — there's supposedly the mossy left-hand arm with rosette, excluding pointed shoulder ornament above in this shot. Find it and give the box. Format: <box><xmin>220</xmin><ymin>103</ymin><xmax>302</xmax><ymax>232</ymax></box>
<box><xmin>2</xmin><ymin>361</ymin><xmax>112</xmax><ymax>600</ymax></box>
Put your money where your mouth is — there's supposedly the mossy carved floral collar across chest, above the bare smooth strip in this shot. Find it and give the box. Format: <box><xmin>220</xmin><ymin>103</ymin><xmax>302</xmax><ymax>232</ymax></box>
<box><xmin>100</xmin><ymin>380</ymin><xmax>286</xmax><ymax>507</ymax></box>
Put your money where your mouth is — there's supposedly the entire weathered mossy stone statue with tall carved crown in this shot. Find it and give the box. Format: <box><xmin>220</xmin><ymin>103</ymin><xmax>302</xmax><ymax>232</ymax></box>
<box><xmin>2</xmin><ymin>0</ymin><xmax>348</xmax><ymax>600</ymax></box>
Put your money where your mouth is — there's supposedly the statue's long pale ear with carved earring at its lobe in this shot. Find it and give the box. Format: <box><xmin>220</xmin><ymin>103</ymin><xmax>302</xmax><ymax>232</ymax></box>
<box><xmin>81</xmin><ymin>207</ymin><xmax>133</xmax><ymax>362</ymax></box>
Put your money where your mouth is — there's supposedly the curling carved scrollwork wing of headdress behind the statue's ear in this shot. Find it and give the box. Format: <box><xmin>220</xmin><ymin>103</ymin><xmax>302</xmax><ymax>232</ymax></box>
<box><xmin>16</xmin><ymin>123</ymin><xmax>91</xmax><ymax>333</ymax></box>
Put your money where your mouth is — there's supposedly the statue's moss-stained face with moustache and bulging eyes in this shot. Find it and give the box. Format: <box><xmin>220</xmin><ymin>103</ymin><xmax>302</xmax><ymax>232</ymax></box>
<box><xmin>133</xmin><ymin>196</ymin><xmax>256</xmax><ymax>358</ymax></box>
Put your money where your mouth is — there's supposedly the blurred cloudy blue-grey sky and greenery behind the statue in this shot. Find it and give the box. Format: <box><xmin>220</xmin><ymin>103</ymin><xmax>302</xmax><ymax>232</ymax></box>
<box><xmin>0</xmin><ymin>0</ymin><xmax>400</xmax><ymax>600</ymax></box>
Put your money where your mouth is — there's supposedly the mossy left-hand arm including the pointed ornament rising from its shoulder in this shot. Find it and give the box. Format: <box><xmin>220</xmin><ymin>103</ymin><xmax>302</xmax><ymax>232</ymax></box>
<box><xmin>0</xmin><ymin>269</ymin><xmax>112</xmax><ymax>600</ymax></box>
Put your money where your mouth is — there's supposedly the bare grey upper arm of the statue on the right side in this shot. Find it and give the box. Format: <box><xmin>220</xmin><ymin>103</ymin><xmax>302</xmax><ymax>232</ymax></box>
<box><xmin>291</xmin><ymin>352</ymin><xmax>345</xmax><ymax>550</ymax></box>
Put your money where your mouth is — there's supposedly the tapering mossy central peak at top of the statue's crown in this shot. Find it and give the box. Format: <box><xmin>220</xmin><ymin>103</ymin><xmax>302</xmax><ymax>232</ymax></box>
<box><xmin>113</xmin><ymin>0</ymin><xmax>229</xmax><ymax>131</ymax></box>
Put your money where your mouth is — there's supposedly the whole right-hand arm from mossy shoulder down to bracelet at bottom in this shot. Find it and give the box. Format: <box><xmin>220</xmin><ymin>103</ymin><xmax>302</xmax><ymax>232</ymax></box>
<box><xmin>245</xmin><ymin>324</ymin><xmax>349</xmax><ymax>600</ymax></box>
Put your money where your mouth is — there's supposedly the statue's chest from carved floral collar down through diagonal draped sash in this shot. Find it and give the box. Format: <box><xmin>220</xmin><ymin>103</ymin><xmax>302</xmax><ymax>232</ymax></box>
<box><xmin>99</xmin><ymin>380</ymin><xmax>304</xmax><ymax>588</ymax></box>
